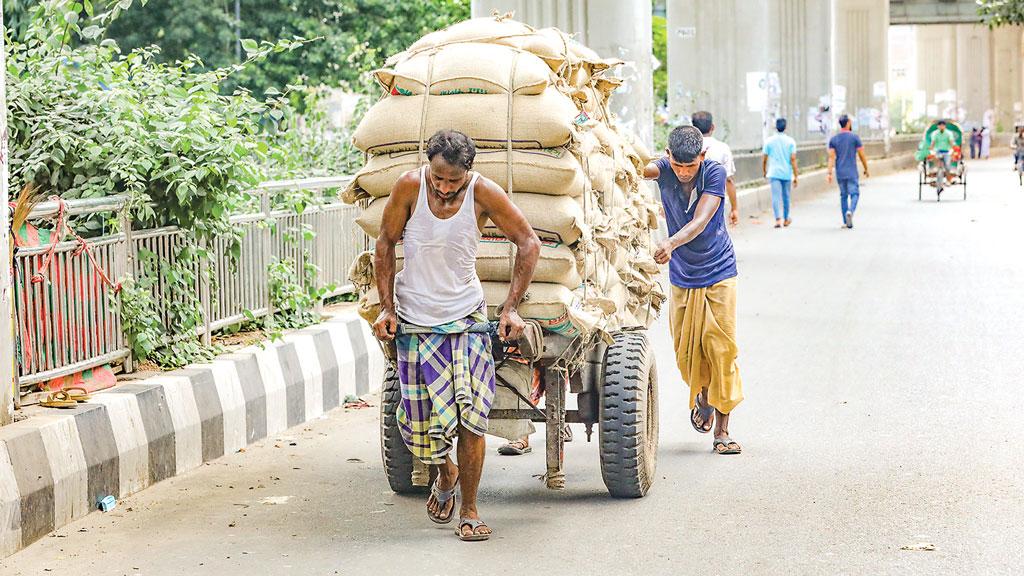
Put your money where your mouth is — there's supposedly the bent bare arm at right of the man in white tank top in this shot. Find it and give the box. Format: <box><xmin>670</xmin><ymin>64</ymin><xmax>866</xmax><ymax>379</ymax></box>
<box><xmin>473</xmin><ymin>178</ymin><xmax>541</xmax><ymax>340</ymax></box>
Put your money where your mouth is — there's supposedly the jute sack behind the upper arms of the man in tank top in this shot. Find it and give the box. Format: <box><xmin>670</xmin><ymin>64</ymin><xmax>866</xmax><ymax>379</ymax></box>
<box><xmin>355</xmin><ymin>194</ymin><xmax>589</xmax><ymax>245</ymax></box>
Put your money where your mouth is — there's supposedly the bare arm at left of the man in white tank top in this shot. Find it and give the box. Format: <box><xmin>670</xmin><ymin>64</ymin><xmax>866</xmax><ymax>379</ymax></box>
<box><xmin>373</xmin><ymin>172</ymin><xmax>420</xmax><ymax>340</ymax></box>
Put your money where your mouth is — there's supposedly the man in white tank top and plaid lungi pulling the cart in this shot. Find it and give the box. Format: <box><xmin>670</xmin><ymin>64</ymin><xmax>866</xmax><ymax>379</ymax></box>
<box><xmin>373</xmin><ymin>130</ymin><xmax>541</xmax><ymax>540</ymax></box>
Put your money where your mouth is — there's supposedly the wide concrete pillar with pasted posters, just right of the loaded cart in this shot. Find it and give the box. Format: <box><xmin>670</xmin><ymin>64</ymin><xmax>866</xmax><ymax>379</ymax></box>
<box><xmin>668</xmin><ymin>0</ymin><xmax>831</xmax><ymax>149</ymax></box>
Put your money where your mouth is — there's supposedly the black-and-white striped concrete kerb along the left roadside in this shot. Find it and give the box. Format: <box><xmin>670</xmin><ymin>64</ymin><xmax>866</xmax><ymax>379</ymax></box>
<box><xmin>0</xmin><ymin>312</ymin><xmax>385</xmax><ymax>558</ymax></box>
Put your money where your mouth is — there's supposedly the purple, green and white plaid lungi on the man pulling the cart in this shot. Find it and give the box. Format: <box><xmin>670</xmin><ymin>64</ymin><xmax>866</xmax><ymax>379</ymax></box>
<box><xmin>396</xmin><ymin>312</ymin><xmax>495</xmax><ymax>464</ymax></box>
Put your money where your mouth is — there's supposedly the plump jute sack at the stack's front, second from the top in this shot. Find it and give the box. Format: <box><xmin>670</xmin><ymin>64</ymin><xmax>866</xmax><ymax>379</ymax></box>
<box><xmin>374</xmin><ymin>42</ymin><xmax>552</xmax><ymax>96</ymax></box>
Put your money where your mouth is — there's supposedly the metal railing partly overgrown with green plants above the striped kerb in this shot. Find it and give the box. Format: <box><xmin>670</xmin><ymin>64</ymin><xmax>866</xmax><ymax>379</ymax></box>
<box><xmin>13</xmin><ymin>176</ymin><xmax>367</xmax><ymax>395</ymax></box>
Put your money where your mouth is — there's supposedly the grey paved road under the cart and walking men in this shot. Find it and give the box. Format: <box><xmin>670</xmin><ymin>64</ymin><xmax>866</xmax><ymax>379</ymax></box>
<box><xmin>0</xmin><ymin>160</ymin><xmax>1024</xmax><ymax>576</ymax></box>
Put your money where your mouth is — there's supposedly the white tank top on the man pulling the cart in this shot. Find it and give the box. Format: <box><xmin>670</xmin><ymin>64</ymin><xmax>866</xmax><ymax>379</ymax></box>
<box><xmin>394</xmin><ymin>166</ymin><xmax>483</xmax><ymax>326</ymax></box>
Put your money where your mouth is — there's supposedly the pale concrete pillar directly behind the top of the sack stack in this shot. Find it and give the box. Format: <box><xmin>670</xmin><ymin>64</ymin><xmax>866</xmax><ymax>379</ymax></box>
<box><xmin>472</xmin><ymin>0</ymin><xmax>654</xmax><ymax>146</ymax></box>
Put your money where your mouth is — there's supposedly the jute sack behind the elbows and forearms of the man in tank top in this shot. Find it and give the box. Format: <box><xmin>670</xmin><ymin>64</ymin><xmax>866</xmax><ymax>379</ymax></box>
<box><xmin>387</xmin><ymin>238</ymin><xmax>583</xmax><ymax>289</ymax></box>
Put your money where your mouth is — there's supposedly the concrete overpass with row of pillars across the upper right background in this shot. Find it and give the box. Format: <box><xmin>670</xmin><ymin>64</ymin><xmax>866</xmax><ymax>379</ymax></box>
<box><xmin>472</xmin><ymin>0</ymin><xmax>1024</xmax><ymax>149</ymax></box>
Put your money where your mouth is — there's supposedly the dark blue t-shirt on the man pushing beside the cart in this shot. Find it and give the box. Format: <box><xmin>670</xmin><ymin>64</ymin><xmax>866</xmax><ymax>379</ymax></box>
<box><xmin>654</xmin><ymin>157</ymin><xmax>736</xmax><ymax>288</ymax></box>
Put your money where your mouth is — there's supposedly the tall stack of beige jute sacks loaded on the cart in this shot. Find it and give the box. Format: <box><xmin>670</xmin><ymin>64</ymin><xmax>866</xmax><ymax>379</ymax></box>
<box><xmin>342</xmin><ymin>16</ymin><xmax>666</xmax><ymax>336</ymax></box>
